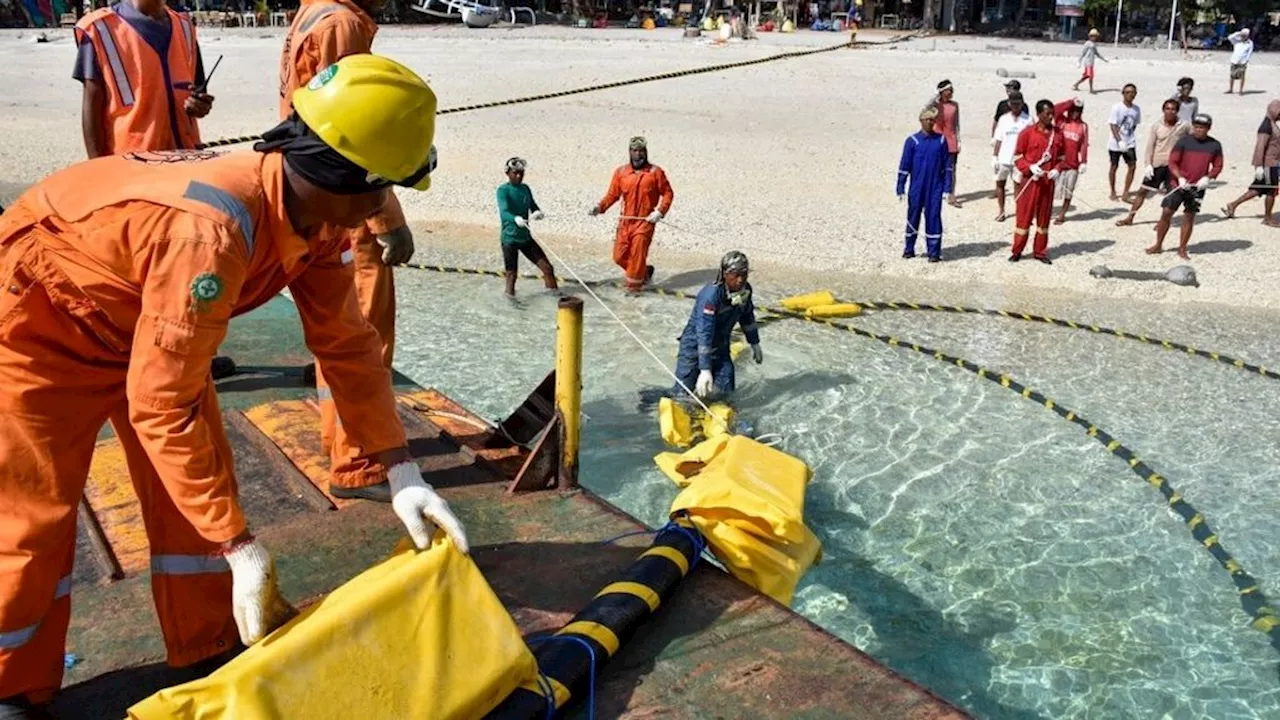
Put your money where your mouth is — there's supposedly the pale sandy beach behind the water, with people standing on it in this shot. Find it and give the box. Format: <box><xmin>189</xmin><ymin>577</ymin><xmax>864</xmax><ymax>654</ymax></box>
<box><xmin>0</xmin><ymin>27</ymin><xmax>1280</xmax><ymax>309</ymax></box>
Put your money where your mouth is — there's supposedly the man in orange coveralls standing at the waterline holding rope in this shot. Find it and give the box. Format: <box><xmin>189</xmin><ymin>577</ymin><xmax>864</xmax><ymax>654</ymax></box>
<box><xmin>590</xmin><ymin>137</ymin><xmax>675</xmax><ymax>292</ymax></box>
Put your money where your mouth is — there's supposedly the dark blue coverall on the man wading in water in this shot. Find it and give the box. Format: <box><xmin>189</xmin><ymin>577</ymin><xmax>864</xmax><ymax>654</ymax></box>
<box><xmin>672</xmin><ymin>283</ymin><xmax>760</xmax><ymax>396</ymax></box>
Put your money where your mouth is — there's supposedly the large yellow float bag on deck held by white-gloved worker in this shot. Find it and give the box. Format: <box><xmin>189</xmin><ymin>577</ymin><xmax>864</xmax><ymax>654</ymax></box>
<box><xmin>129</xmin><ymin>533</ymin><xmax>538</xmax><ymax>720</ymax></box>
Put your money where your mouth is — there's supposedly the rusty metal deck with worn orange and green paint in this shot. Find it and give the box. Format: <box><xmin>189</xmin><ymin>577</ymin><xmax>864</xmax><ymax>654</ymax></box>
<box><xmin>58</xmin><ymin>299</ymin><xmax>965</xmax><ymax>719</ymax></box>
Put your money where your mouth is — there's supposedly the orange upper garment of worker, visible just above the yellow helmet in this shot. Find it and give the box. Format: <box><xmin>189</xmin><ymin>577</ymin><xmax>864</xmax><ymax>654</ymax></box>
<box><xmin>280</xmin><ymin>0</ymin><xmax>378</xmax><ymax>119</ymax></box>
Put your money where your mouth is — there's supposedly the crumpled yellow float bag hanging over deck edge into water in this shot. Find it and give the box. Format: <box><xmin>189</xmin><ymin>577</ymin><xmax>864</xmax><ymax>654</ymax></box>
<box><xmin>654</xmin><ymin>436</ymin><xmax>822</xmax><ymax>605</ymax></box>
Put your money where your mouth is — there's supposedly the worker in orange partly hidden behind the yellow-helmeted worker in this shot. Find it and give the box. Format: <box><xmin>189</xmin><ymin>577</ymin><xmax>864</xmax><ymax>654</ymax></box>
<box><xmin>280</xmin><ymin>0</ymin><xmax>413</xmax><ymax>484</ymax></box>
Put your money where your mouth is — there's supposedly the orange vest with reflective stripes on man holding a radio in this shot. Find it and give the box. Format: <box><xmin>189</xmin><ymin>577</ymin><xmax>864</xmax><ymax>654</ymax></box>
<box><xmin>76</xmin><ymin>8</ymin><xmax>200</xmax><ymax>155</ymax></box>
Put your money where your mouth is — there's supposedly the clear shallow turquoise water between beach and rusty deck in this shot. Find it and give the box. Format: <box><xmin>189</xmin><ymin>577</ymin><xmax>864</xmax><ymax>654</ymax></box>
<box><xmin>397</xmin><ymin>265</ymin><xmax>1280</xmax><ymax>719</ymax></box>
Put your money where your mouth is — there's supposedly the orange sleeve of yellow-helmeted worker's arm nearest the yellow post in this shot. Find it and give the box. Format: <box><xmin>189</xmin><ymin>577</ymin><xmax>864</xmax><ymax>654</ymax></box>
<box><xmin>289</xmin><ymin>238</ymin><xmax>407</xmax><ymax>456</ymax></box>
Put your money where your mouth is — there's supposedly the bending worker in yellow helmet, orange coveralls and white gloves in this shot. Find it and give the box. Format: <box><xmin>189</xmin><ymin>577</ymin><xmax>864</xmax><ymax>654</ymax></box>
<box><xmin>0</xmin><ymin>55</ymin><xmax>467</xmax><ymax>717</ymax></box>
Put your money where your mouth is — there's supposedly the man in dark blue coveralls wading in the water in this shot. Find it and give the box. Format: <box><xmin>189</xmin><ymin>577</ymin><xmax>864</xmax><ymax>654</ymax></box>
<box><xmin>672</xmin><ymin>250</ymin><xmax>764</xmax><ymax>397</ymax></box>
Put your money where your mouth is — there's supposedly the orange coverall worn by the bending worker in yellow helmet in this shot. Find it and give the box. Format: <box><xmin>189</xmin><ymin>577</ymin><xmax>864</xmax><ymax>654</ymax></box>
<box><xmin>0</xmin><ymin>152</ymin><xmax>404</xmax><ymax>700</ymax></box>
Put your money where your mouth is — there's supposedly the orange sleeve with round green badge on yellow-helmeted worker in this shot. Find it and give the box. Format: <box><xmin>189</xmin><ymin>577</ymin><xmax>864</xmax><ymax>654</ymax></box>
<box><xmin>125</xmin><ymin>209</ymin><xmax>248</xmax><ymax>542</ymax></box>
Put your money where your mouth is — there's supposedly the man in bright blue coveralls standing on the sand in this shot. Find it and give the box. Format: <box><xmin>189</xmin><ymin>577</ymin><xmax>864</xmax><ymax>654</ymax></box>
<box><xmin>897</xmin><ymin>108</ymin><xmax>955</xmax><ymax>263</ymax></box>
